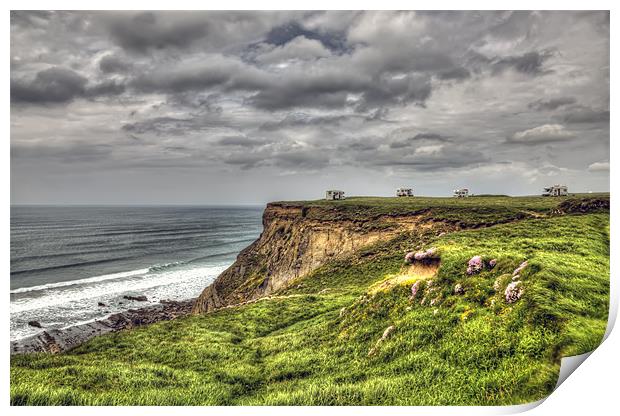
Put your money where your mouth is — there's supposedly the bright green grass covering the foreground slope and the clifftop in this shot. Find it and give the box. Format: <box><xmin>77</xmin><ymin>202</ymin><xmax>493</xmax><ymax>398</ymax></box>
<box><xmin>11</xmin><ymin>197</ymin><xmax>609</xmax><ymax>405</ymax></box>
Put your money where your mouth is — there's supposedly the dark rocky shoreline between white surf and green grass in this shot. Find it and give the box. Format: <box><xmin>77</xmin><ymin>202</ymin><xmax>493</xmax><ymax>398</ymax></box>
<box><xmin>11</xmin><ymin>299</ymin><xmax>195</xmax><ymax>354</ymax></box>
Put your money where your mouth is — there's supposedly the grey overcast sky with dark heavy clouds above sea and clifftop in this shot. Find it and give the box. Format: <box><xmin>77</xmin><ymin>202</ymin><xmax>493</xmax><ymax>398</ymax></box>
<box><xmin>11</xmin><ymin>12</ymin><xmax>609</xmax><ymax>204</ymax></box>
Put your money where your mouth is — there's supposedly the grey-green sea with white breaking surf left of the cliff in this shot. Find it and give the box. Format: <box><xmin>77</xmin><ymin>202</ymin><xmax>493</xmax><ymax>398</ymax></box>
<box><xmin>10</xmin><ymin>206</ymin><xmax>263</xmax><ymax>340</ymax></box>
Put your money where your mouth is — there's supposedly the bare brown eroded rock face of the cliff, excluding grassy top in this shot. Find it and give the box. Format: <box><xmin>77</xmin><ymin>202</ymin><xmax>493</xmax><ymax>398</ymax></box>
<box><xmin>193</xmin><ymin>203</ymin><xmax>432</xmax><ymax>313</ymax></box>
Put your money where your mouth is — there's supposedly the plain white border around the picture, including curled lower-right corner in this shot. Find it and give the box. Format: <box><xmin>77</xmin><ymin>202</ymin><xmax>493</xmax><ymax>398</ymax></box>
<box><xmin>0</xmin><ymin>0</ymin><xmax>620</xmax><ymax>416</ymax></box>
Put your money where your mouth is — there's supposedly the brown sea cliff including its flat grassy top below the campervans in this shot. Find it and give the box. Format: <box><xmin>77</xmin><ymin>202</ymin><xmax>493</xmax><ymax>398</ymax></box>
<box><xmin>192</xmin><ymin>195</ymin><xmax>609</xmax><ymax>313</ymax></box>
